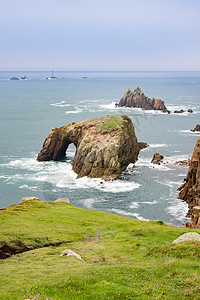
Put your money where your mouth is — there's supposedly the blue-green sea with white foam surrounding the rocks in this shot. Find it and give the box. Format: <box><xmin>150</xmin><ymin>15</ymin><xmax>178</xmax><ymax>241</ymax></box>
<box><xmin>0</xmin><ymin>72</ymin><xmax>200</xmax><ymax>226</ymax></box>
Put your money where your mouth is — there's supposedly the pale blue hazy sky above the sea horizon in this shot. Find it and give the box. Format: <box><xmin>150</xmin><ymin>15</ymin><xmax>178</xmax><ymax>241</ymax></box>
<box><xmin>0</xmin><ymin>0</ymin><xmax>200</xmax><ymax>71</ymax></box>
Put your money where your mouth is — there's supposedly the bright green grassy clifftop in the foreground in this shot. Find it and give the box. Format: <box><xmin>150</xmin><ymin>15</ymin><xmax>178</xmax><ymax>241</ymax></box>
<box><xmin>0</xmin><ymin>200</ymin><xmax>200</xmax><ymax>300</ymax></box>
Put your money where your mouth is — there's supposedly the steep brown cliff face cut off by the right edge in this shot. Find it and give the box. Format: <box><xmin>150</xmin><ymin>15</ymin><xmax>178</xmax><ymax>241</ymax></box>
<box><xmin>178</xmin><ymin>138</ymin><xmax>200</xmax><ymax>228</ymax></box>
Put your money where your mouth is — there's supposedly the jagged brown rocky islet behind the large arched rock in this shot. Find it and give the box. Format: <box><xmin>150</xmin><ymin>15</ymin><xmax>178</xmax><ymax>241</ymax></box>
<box><xmin>116</xmin><ymin>87</ymin><xmax>169</xmax><ymax>113</ymax></box>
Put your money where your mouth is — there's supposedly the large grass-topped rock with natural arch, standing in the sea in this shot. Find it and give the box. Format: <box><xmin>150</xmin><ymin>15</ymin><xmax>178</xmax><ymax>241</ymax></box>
<box><xmin>37</xmin><ymin>115</ymin><xmax>139</xmax><ymax>180</ymax></box>
